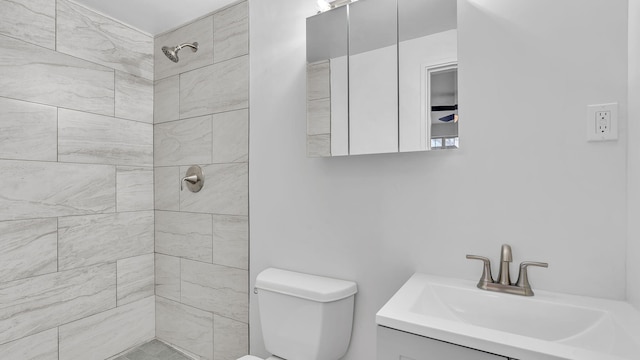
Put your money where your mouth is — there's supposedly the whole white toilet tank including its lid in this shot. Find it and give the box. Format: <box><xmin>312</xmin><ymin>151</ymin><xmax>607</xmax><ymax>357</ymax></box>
<box><xmin>255</xmin><ymin>268</ymin><xmax>357</xmax><ymax>360</ymax></box>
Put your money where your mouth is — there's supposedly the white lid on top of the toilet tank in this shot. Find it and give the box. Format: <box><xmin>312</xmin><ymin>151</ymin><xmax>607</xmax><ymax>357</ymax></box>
<box><xmin>256</xmin><ymin>268</ymin><xmax>358</xmax><ymax>302</ymax></box>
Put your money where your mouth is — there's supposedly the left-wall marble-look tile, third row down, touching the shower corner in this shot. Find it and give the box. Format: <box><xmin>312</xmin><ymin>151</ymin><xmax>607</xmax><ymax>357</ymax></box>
<box><xmin>58</xmin><ymin>109</ymin><xmax>153</xmax><ymax>166</ymax></box>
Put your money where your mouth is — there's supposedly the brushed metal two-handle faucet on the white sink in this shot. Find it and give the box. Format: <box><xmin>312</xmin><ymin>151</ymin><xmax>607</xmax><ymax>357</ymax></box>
<box><xmin>467</xmin><ymin>244</ymin><xmax>549</xmax><ymax>296</ymax></box>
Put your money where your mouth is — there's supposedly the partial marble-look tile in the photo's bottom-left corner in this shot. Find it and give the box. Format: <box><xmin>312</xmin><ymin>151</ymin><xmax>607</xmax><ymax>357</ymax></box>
<box><xmin>0</xmin><ymin>328</ymin><xmax>58</xmax><ymax>360</ymax></box>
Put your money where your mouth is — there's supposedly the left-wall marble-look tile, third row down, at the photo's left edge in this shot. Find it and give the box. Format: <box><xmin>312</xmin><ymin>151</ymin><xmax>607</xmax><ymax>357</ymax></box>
<box><xmin>0</xmin><ymin>98</ymin><xmax>58</xmax><ymax>161</ymax></box>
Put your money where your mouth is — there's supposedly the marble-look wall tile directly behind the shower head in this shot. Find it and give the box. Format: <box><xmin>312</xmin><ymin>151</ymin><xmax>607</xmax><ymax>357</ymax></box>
<box><xmin>154</xmin><ymin>16</ymin><xmax>213</xmax><ymax>80</ymax></box>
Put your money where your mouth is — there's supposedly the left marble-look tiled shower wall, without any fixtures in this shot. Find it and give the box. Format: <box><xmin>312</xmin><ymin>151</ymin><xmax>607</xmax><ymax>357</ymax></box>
<box><xmin>0</xmin><ymin>0</ymin><xmax>155</xmax><ymax>360</ymax></box>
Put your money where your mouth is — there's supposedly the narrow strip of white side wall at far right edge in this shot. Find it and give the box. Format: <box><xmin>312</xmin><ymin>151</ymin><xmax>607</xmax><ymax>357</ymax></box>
<box><xmin>627</xmin><ymin>0</ymin><xmax>640</xmax><ymax>309</ymax></box>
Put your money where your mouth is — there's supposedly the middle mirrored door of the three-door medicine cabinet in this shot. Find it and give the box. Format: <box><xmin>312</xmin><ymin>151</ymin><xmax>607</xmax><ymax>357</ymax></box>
<box><xmin>349</xmin><ymin>0</ymin><xmax>398</xmax><ymax>155</ymax></box>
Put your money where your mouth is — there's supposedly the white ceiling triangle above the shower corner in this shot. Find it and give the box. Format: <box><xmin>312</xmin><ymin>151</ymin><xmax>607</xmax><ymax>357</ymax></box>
<box><xmin>74</xmin><ymin>0</ymin><xmax>238</xmax><ymax>35</ymax></box>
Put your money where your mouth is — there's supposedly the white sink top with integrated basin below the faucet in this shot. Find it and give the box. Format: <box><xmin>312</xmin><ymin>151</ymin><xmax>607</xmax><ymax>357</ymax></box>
<box><xmin>376</xmin><ymin>274</ymin><xmax>640</xmax><ymax>360</ymax></box>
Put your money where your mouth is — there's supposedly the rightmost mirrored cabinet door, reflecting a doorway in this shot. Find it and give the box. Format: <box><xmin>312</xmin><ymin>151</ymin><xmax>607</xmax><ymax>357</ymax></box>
<box><xmin>398</xmin><ymin>0</ymin><xmax>459</xmax><ymax>152</ymax></box>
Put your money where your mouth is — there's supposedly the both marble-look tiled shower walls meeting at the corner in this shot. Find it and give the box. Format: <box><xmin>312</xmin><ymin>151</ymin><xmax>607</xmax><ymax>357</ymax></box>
<box><xmin>0</xmin><ymin>0</ymin><xmax>249</xmax><ymax>360</ymax></box>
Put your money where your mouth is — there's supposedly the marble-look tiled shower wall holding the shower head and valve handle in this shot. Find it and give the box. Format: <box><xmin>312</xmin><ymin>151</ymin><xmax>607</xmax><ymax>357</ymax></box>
<box><xmin>154</xmin><ymin>2</ymin><xmax>249</xmax><ymax>360</ymax></box>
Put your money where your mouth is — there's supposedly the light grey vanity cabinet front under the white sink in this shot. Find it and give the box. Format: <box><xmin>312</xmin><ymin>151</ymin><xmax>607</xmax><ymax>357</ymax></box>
<box><xmin>377</xmin><ymin>326</ymin><xmax>509</xmax><ymax>360</ymax></box>
